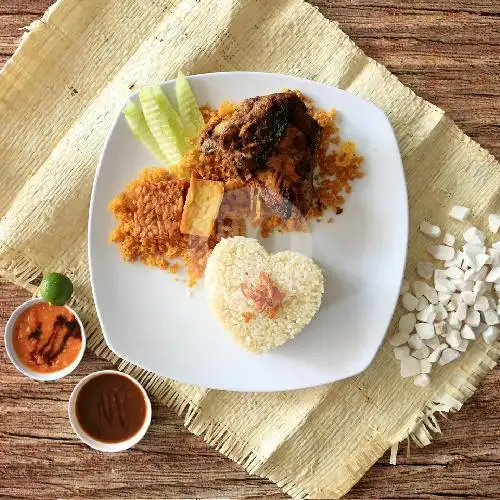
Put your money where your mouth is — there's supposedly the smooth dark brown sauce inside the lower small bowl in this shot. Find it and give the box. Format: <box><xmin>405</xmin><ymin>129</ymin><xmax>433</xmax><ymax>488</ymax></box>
<box><xmin>75</xmin><ymin>373</ymin><xmax>146</xmax><ymax>443</ymax></box>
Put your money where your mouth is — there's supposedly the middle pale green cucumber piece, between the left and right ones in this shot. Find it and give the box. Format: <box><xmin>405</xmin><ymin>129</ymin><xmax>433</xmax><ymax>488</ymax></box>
<box><xmin>139</xmin><ymin>86</ymin><xmax>187</xmax><ymax>166</ymax></box>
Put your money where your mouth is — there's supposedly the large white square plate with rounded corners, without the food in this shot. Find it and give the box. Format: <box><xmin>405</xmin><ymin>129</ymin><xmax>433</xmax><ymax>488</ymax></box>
<box><xmin>89</xmin><ymin>72</ymin><xmax>408</xmax><ymax>391</ymax></box>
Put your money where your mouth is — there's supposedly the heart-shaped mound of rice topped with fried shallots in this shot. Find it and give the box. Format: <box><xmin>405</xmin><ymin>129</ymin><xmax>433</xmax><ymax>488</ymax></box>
<box><xmin>205</xmin><ymin>236</ymin><xmax>324</xmax><ymax>353</ymax></box>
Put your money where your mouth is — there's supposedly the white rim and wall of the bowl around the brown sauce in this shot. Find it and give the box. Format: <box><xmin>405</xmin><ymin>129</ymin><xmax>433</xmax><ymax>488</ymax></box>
<box><xmin>68</xmin><ymin>370</ymin><xmax>151</xmax><ymax>453</ymax></box>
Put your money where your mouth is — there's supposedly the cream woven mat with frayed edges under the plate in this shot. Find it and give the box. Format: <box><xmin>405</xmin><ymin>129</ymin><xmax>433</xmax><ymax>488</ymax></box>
<box><xmin>0</xmin><ymin>0</ymin><xmax>500</xmax><ymax>498</ymax></box>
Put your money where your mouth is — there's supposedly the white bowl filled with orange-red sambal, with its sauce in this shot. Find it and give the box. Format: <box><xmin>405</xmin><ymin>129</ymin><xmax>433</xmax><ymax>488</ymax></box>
<box><xmin>5</xmin><ymin>298</ymin><xmax>86</xmax><ymax>382</ymax></box>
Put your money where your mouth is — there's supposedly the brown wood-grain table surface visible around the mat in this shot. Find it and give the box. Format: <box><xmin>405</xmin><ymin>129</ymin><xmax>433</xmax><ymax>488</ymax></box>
<box><xmin>0</xmin><ymin>0</ymin><xmax>500</xmax><ymax>499</ymax></box>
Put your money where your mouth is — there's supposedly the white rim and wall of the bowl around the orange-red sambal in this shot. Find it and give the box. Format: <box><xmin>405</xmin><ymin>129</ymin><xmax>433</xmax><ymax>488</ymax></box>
<box><xmin>5</xmin><ymin>298</ymin><xmax>87</xmax><ymax>382</ymax></box>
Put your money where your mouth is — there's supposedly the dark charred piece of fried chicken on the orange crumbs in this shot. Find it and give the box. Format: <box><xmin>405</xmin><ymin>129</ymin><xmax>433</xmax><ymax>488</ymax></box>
<box><xmin>200</xmin><ymin>92</ymin><xmax>321</xmax><ymax>219</ymax></box>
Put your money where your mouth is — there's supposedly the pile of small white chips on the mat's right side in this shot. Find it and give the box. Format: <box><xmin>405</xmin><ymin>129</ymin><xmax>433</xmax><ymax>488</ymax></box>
<box><xmin>389</xmin><ymin>206</ymin><xmax>500</xmax><ymax>387</ymax></box>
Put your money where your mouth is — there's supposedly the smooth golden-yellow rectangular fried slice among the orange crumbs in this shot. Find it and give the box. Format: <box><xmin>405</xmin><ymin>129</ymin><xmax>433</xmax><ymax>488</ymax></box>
<box><xmin>181</xmin><ymin>176</ymin><xmax>224</xmax><ymax>238</ymax></box>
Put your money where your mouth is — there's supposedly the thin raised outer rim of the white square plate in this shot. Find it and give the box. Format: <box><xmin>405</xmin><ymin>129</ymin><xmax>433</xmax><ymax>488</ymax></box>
<box><xmin>87</xmin><ymin>71</ymin><xmax>409</xmax><ymax>393</ymax></box>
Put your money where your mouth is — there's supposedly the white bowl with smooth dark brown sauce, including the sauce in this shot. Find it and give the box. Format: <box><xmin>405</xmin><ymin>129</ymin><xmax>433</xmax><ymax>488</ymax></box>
<box><xmin>68</xmin><ymin>370</ymin><xmax>151</xmax><ymax>452</ymax></box>
